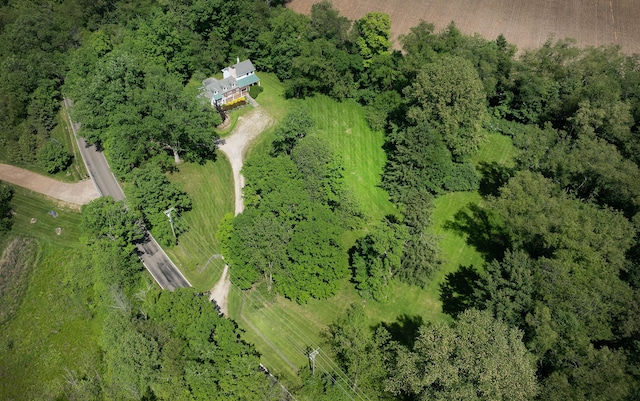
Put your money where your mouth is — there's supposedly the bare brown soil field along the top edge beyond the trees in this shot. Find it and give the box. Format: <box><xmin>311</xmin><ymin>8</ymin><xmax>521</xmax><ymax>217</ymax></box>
<box><xmin>288</xmin><ymin>0</ymin><xmax>640</xmax><ymax>54</ymax></box>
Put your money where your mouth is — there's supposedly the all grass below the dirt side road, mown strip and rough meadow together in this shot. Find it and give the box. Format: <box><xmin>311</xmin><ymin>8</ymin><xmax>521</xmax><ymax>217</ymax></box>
<box><xmin>0</xmin><ymin>188</ymin><xmax>101</xmax><ymax>400</ymax></box>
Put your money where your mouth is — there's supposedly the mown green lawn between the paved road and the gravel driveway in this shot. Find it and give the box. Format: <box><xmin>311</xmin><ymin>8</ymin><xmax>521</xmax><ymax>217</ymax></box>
<box><xmin>166</xmin><ymin>152</ymin><xmax>235</xmax><ymax>291</ymax></box>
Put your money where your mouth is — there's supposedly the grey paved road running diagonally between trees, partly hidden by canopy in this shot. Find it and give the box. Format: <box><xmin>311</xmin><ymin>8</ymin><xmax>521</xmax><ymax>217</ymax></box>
<box><xmin>64</xmin><ymin>99</ymin><xmax>191</xmax><ymax>290</ymax></box>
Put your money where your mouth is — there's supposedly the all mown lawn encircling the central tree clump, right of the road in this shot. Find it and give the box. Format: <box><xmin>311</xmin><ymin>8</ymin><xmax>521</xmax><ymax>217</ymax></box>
<box><xmin>169</xmin><ymin>69</ymin><xmax>514</xmax><ymax>384</ymax></box>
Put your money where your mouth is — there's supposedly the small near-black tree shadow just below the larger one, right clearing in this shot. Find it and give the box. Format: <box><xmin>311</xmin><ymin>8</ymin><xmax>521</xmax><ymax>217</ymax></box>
<box><xmin>440</xmin><ymin>265</ymin><xmax>480</xmax><ymax>317</ymax></box>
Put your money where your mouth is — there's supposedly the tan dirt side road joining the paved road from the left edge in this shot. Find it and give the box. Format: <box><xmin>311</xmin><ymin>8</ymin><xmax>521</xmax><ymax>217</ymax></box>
<box><xmin>0</xmin><ymin>164</ymin><xmax>100</xmax><ymax>207</ymax></box>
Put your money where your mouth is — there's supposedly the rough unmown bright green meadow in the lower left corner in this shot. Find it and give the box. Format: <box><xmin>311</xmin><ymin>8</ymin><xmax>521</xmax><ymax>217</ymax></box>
<box><xmin>0</xmin><ymin>242</ymin><xmax>101</xmax><ymax>400</ymax></box>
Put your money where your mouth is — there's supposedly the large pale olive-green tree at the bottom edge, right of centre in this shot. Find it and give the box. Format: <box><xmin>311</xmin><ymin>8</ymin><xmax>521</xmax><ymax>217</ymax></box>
<box><xmin>386</xmin><ymin>309</ymin><xmax>539</xmax><ymax>401</ymax></box>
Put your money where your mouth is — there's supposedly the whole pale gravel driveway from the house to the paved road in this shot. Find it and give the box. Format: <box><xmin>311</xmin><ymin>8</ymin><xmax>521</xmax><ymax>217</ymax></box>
<box><xmin>209</xmin><ymin>105</ymin><xmax>273</xmax><ymax>316</ymax></box>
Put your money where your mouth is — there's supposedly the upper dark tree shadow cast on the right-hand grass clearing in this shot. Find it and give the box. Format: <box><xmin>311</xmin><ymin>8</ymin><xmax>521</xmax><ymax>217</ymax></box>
<box><xmin>444</xmin><ymin>203</ymin><xmax>508</xmax><ymax>261</ymax></box>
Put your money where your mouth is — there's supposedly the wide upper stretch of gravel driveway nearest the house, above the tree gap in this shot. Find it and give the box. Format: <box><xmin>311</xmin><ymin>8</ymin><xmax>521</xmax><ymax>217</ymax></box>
<box><xmin>219</xmin><ymin>106</ymin><xmax>272</xmax><ymax>215</ymax></box>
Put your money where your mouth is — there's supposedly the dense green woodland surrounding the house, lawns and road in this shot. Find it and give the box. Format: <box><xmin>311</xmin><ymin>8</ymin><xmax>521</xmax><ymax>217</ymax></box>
<box><xmin>0</xmin><ymin>0</ymin><xmax>640</xmax><ymax>400</ymax></box>
